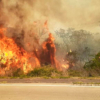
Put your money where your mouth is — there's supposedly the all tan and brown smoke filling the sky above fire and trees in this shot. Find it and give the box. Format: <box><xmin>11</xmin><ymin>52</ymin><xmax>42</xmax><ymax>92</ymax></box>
<box><xmin>0</xmin><ymin>0</ymin><xmax>100</xmax><ymax>64</ymax></box>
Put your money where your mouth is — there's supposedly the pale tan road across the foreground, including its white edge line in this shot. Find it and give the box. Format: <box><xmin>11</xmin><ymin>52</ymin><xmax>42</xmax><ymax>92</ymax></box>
<box><xmin>0</xmin><ymin>83</ymin><xmax>100</xmax><ymax>100</ymax></box>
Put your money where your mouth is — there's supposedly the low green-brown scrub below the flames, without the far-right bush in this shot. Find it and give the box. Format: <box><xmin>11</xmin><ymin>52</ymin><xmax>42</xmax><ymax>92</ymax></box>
<box><xmin>0</xmin><ymin>66</ymin><xmax>87</xmax><ymax>79</ymax></box>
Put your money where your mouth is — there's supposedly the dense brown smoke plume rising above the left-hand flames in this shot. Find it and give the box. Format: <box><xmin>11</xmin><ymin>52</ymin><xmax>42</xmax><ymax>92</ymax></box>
<box><xmin>0</xmin><ymin>0</ymin><xmax>48</xmax><ymax>51</ymax></box>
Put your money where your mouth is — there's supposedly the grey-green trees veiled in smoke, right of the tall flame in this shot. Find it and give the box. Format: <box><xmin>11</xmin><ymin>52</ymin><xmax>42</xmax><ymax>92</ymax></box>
<box><xmin>55</xmin><ymin>29</ymin><xmax>100</xmax><ymax>69</ymax></box>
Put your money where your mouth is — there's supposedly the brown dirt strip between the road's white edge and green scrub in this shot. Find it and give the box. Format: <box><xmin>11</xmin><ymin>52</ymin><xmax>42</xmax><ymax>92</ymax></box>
<box><xmin>0</xmin><ymin>78</ymin><xmax>100</xmax><ymax>84</ymax></box>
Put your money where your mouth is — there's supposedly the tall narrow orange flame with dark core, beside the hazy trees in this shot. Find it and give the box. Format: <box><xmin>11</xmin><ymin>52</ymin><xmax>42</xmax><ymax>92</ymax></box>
<box><xmin>42</xmin><ymin>33</ymin><xmax>56</xmax><ymax>65</ymax></box>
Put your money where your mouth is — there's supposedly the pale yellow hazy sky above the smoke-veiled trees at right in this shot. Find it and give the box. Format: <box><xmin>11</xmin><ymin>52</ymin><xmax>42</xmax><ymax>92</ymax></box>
<box><xmin>48</xmin><ymin>0</ymin><xmax>100</xmax><ymax>32</ymax></box>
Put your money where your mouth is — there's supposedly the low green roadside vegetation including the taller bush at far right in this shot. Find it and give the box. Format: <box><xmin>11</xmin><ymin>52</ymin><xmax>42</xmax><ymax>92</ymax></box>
<box><xmin>0</xmin><ymin>61</ymin><xmax>100</xmax><ymax>79</ymax></box>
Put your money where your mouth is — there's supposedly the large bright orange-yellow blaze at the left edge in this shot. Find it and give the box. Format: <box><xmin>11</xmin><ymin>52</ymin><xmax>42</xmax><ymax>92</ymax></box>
<box><xmin>0</xmin><ymin>28</ymin><xmax>40</xmax><ymax>73</ymax></box>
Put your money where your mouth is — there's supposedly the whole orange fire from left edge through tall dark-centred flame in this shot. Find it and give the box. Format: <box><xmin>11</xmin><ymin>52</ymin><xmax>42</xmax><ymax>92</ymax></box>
<box><xmin>0</xmin><ymin>22</ymin><xmax>56</xmax><ymax>75</ymax></box>
